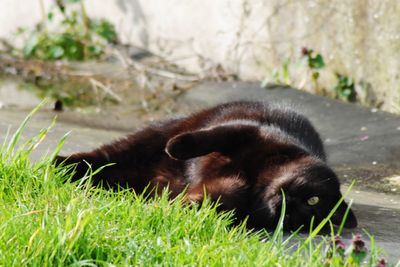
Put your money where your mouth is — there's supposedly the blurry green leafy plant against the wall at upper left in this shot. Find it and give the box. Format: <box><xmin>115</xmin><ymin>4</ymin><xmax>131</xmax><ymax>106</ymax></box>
<box><xmin>18</xmin><ymin>0</ymin><xmax>117</xmax><ymax>60</ymax></box>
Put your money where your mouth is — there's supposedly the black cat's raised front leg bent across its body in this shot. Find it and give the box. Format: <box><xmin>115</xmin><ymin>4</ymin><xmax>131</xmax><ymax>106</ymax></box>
<box><xmin>165</xmin><ymin>125</ymin><xmax>260</xmax><ymax>160</ymax></box>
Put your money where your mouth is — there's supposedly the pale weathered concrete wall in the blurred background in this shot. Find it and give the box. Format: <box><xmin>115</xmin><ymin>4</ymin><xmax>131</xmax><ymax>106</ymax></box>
<box><xmin>0</xmin><ymin>0</ymin><xmax>400</xmax><ymax>110</ymax></box>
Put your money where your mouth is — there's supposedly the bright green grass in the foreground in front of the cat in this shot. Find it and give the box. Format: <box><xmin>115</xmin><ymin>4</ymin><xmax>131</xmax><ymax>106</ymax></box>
<box><xmin>0</xmin><ymin>108</ymin><xmax>390</xmax><ymax>266</ymax></box>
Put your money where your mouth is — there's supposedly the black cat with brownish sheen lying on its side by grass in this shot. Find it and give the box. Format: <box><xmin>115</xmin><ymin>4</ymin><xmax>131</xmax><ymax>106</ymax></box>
<box><xmin>56</xmin><ymin>101</ymin><xmax>357</xmax><ymax>230</ymax></box>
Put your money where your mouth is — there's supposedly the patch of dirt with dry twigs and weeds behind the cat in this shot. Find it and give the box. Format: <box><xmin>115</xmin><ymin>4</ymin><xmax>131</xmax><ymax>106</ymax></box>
<box><xmin>0</xmin><ymin>50</ymin><xmax>199</xmax><ymax>125</ymax></box>
